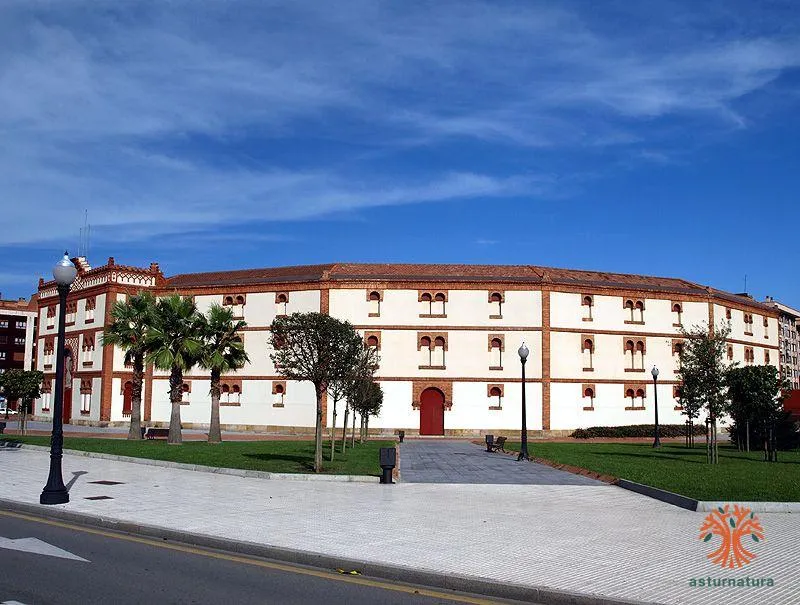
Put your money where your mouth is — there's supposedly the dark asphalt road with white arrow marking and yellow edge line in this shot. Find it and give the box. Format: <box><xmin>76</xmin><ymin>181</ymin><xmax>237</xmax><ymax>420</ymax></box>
<box><xmin>0</xmin><ymin>511</ymin><xmax>524</xmax><ymax>605</ymax></box>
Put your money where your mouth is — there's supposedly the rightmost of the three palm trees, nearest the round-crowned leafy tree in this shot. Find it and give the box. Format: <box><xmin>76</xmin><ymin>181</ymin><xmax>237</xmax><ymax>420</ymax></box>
<box><xmin>199</xmin><ymin>304</ymin><xmax>250</xmax><ymax>443</ymax></box>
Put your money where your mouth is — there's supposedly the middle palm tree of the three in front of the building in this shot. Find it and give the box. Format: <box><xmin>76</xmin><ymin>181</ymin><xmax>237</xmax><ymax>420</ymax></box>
<box><xmin>145</xmin><ymin>294</ymin><xmax>203</xmax><ymax>444</ymax></box>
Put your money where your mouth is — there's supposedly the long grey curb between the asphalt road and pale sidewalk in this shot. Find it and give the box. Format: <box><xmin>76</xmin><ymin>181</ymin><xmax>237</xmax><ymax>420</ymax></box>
<box><xmin>0</xmin><ymin>498</ymin><xmax>658</xmax><ymax>605</ymax></box>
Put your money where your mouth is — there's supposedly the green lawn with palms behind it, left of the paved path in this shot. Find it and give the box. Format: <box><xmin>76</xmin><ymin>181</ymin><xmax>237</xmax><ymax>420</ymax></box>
<box><xmin>0</xmin><ymin>436</ymin><xmax>394</xmax><ymax>476</ymax></box>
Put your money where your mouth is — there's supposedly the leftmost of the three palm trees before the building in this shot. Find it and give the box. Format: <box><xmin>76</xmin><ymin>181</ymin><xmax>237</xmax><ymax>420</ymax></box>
<box><xmin>103</xmin><ymin>292</ymin><xmax>156</xmax><ymax>439</ymax></box>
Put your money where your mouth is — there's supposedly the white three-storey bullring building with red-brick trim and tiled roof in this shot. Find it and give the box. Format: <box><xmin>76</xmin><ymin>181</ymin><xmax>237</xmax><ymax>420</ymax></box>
<box><xmin>35</xmin><ymin>257</ymin><xmax>779</xmax><ymax>435</ymax></box>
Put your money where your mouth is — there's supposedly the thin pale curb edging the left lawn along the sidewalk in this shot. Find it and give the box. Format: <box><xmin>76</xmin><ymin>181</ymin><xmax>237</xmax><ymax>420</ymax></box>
<box><xmin>0</xmin><ymin>440</ymin><xmax>380</xmax><ymax>483</ymax></box>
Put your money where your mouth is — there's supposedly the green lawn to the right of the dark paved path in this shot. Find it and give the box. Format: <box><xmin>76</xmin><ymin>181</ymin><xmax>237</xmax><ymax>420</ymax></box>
<box><xmin>505</xmin><ymin>441</ymin><xmax>800</xmax><ymax>502</ymax></box>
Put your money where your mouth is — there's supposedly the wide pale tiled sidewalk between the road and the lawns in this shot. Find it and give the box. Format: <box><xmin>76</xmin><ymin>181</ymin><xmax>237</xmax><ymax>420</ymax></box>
<box><xmin>0</xmin><ymin>449</ymin><xmax>800</xmax><ymax>605</ymax></box>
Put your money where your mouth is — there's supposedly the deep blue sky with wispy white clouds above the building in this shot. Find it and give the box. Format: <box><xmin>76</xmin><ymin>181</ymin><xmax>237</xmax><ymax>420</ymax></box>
<box><xmin>0</xmin><ymin>0</ymin><xmax>800</xmax><ymax>307</ymax></box>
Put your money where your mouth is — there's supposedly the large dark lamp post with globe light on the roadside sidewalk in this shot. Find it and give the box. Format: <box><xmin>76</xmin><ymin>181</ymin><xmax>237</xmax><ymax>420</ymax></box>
<box><xmin>39</xmin><ymin>252</ymin><xmax>78</xmax><ymax>504</ymax></box>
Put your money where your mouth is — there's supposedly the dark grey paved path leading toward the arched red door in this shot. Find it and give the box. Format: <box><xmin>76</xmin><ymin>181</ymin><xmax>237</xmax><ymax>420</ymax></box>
<box><xmin>400</xmin><ymin>439</ymin><xmax>603</xmax><ymax>486</ymax></box>
